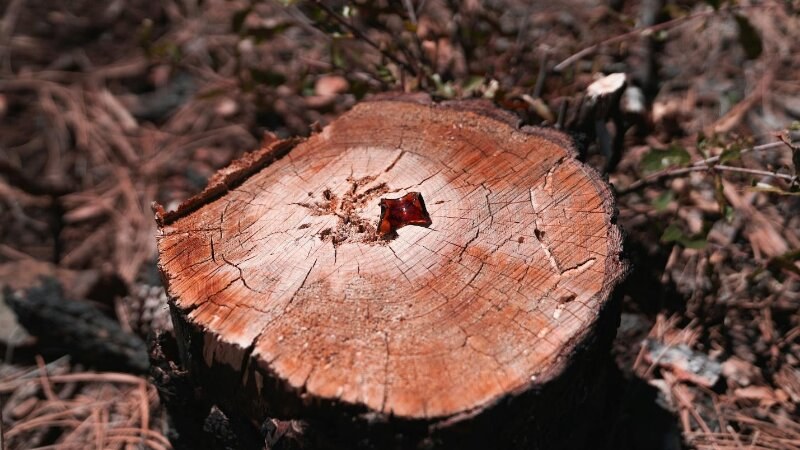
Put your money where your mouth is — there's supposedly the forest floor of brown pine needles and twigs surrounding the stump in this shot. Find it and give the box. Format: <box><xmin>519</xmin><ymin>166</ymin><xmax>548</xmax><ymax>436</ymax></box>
<box><xmin>0</xmin><ymin>0</ymin><xmax>800</xmax><ymax>449</ymax></box>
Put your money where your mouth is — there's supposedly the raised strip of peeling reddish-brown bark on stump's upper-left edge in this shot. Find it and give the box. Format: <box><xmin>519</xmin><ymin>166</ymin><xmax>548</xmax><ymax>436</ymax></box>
<box><xmin>152</xmin><ymin>134</ymin><xmax>305</xmax><ymax>228</ymax></box>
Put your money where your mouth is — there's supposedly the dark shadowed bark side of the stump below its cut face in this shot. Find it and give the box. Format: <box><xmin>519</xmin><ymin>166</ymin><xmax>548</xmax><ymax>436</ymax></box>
<box><xmin>166</xmin><ymin>276</ymin><xmax>621</xmax><ymax>450</ymax></box>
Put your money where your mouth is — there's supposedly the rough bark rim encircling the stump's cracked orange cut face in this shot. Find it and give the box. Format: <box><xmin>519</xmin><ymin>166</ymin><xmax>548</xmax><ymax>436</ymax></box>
<box><xmin>157</xmin><ymin>93</ymin><xmax>628</xmax><ymax>446</ymax></box>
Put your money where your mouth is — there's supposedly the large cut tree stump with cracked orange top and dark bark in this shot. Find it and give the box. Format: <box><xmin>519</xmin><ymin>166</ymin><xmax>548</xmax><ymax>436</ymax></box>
<box><xmin>157</xmin><ymin>96</ymin><xmax>625</xmax><ymax>448</ymax></box>
